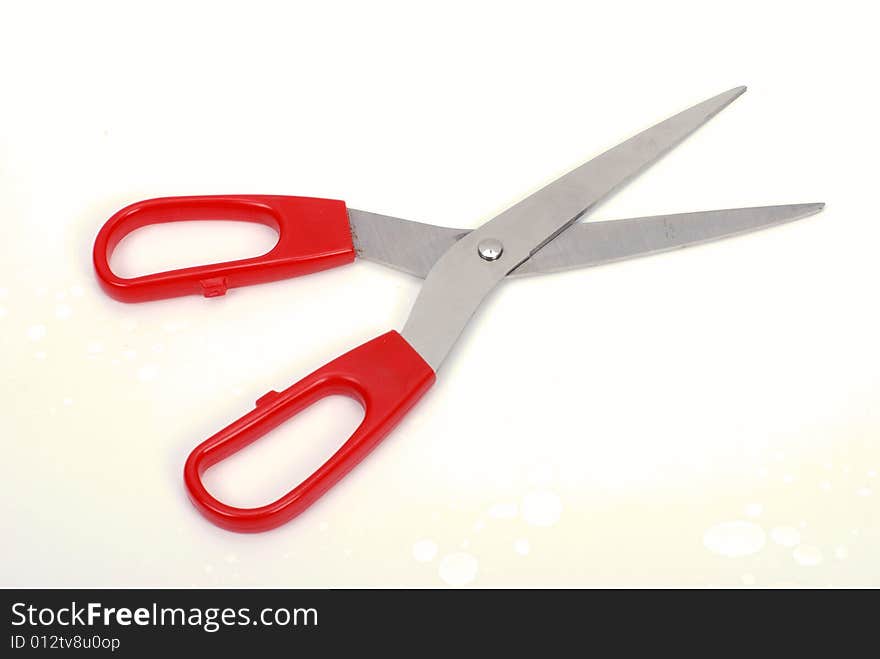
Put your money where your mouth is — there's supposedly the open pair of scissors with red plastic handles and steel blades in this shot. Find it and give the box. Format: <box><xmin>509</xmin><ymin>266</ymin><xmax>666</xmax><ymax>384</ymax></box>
<box><xmin>93</xmin><ymin>87</ymin><xmax>824</xmax><ymax>532</ymax></box>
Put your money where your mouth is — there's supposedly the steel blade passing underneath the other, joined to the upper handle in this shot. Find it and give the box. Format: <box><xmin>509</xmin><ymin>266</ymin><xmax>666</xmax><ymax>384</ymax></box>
<box><xmin>349</xmin><ymin>204</ymin><xmax>825</xmax><ymax>279</ymax></box>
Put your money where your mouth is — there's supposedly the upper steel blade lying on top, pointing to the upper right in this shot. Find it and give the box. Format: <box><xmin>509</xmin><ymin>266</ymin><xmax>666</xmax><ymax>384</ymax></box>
<box><xmin>401</xmin><ymin>87</ymin><xmax>745</xmax><ymax>371</ymax></box>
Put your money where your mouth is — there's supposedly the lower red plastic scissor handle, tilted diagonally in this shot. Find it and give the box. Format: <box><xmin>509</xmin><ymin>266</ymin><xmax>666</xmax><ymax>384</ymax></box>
<box><xmin>183</xmin><ymin>331</ymin><xmax>434</xmax><ymax>533</ymax></box>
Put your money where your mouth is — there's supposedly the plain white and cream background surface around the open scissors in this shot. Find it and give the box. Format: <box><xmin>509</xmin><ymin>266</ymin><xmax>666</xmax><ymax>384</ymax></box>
<box><xmin>0</xmin><ymin>1</ymin><xmax>880</xmax><ymax>586</ymax></box>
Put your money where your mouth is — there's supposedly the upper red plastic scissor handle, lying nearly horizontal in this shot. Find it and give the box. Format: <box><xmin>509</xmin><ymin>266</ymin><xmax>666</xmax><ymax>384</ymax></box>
<box><xmin>93</xmin><ymin>195</ymin><xmax>355</xmax><ymax>302</ymax></box>
